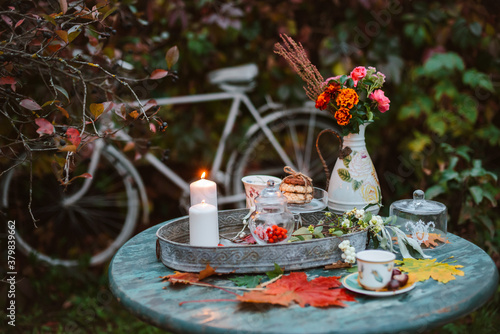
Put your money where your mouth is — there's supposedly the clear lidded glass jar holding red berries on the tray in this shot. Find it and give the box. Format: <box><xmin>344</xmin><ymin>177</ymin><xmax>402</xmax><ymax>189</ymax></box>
<box><xmin>248</xmin><ymin>180</ymin><xmax>295</xmax><ymax>245</ymax></box>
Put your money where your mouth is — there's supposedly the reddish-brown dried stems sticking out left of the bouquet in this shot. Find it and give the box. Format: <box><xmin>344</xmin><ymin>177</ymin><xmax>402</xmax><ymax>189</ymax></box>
<box><xmin>274</xmin><ymin>34</ymin><xmax>324</xmax><ymax>101</ymax></box>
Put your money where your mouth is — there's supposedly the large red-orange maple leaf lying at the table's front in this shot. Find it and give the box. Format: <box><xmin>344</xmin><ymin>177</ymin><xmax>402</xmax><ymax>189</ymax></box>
<box><xmin>237</xmin><ymin>272</ymin><xmax>356</xmax><ymax>307</ymax></box>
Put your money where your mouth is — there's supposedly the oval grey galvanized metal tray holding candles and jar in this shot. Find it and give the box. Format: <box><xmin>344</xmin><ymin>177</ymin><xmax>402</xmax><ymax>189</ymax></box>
<box><xmin>156</xmin><ymin>209</ymin><xmax>368</xmax><ymax>273</ymax></box>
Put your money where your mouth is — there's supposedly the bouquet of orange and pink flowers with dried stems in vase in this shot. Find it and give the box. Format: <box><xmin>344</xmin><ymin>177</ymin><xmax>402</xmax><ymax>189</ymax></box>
<box><xmin>274</xmin><ymin>35</ymin><xmax>391</xmax><ymax>135</ymax></box>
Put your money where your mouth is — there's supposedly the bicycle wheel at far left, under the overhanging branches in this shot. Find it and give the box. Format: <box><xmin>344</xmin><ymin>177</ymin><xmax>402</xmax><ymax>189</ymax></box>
<box><xmin>1</xmin><ymin>146</ymin><xmax>140</xmax><ymax>266</ymax></box>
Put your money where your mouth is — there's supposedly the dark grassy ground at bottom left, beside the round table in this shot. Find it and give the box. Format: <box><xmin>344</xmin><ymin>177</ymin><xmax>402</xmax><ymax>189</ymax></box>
<box><xmin>0</xmin><ymin>254</ymin><xmax>164</xmax><ymax>334</ymax></box>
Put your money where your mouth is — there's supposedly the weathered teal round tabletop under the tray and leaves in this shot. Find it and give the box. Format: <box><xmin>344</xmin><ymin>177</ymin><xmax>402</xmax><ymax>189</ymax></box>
<box><xmin>109</xmin><ymin>218</ymin><xmax>498</xmax><ymax>333</ymax></box>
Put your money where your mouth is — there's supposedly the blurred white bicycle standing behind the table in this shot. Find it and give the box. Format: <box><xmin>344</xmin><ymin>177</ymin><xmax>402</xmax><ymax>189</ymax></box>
<box><xmin>0</xmin><ymin>64</ymin><xmax>336</xmax><ymax>266</ymax></box>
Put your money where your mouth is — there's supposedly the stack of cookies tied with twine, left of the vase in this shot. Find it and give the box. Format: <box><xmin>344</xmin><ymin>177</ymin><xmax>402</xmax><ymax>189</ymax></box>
<box><xmin>280</xmin><ymin>166</ymin><xmax>313</xmax><ymax>204</ymax></box>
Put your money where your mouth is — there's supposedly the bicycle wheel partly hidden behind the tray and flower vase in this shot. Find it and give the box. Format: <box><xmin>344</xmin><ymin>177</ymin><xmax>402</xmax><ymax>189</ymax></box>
<box><xmin>231</xmin><ymin>109</ymin><xmax>338</xmax><ymax>198</ymax></box>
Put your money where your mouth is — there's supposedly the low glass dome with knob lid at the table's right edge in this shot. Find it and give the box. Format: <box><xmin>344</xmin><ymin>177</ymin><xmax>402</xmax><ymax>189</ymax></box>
<box><xmin>390</xmin><ymin>190</ymin><xmax>448</xmax><ymax>249</ymax></box>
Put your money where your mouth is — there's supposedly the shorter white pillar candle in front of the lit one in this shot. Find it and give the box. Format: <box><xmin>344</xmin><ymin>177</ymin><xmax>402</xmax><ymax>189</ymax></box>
<box><xmin>189</xmin><ymin>201</ymin><xmax>219</xmax><ymax>247</ymax></box>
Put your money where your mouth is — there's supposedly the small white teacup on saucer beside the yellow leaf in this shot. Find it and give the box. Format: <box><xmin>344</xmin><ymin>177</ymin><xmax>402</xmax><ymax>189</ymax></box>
<box><xmin>356</xmin><ymin>249</ymin><xmax>396</xmax><ymax>290</ymax></box>
